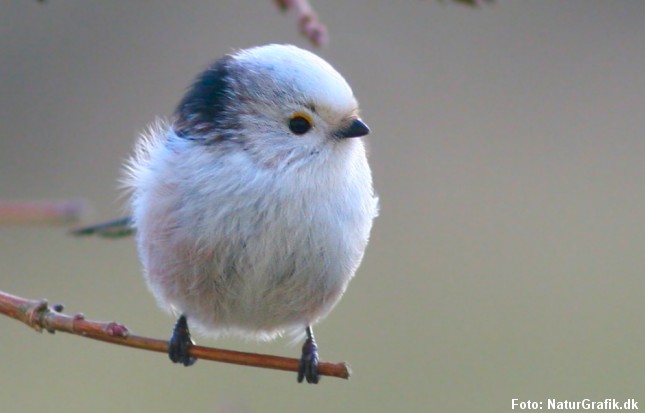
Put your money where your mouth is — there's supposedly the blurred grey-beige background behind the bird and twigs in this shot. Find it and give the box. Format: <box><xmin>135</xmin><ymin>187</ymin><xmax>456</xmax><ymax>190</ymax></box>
<box><xmin>0</xmin><ymin>0</ymin><xmax>645</xmax><ymax>413</ymax></box>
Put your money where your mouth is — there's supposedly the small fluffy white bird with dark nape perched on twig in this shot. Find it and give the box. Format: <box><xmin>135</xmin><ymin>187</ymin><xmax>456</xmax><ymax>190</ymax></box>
<box><xmin>77</xmin><ymin>44</ymin><xmax>378</xmax><ymax>383</ymax></box>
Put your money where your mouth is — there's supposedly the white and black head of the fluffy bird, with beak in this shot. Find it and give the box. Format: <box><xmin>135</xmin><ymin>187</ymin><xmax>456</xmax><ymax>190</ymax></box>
<box><xmin>174</xmin><ymin>44</ymin><xmax>369</xmax><ymax>167</ymax></box>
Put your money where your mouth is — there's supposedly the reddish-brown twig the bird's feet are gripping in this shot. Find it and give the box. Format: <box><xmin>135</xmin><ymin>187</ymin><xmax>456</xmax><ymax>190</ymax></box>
<box><xmin>0</xmin><ymin>291</ymin><xmax>350</xmax><ymax>379</ymax></box>
